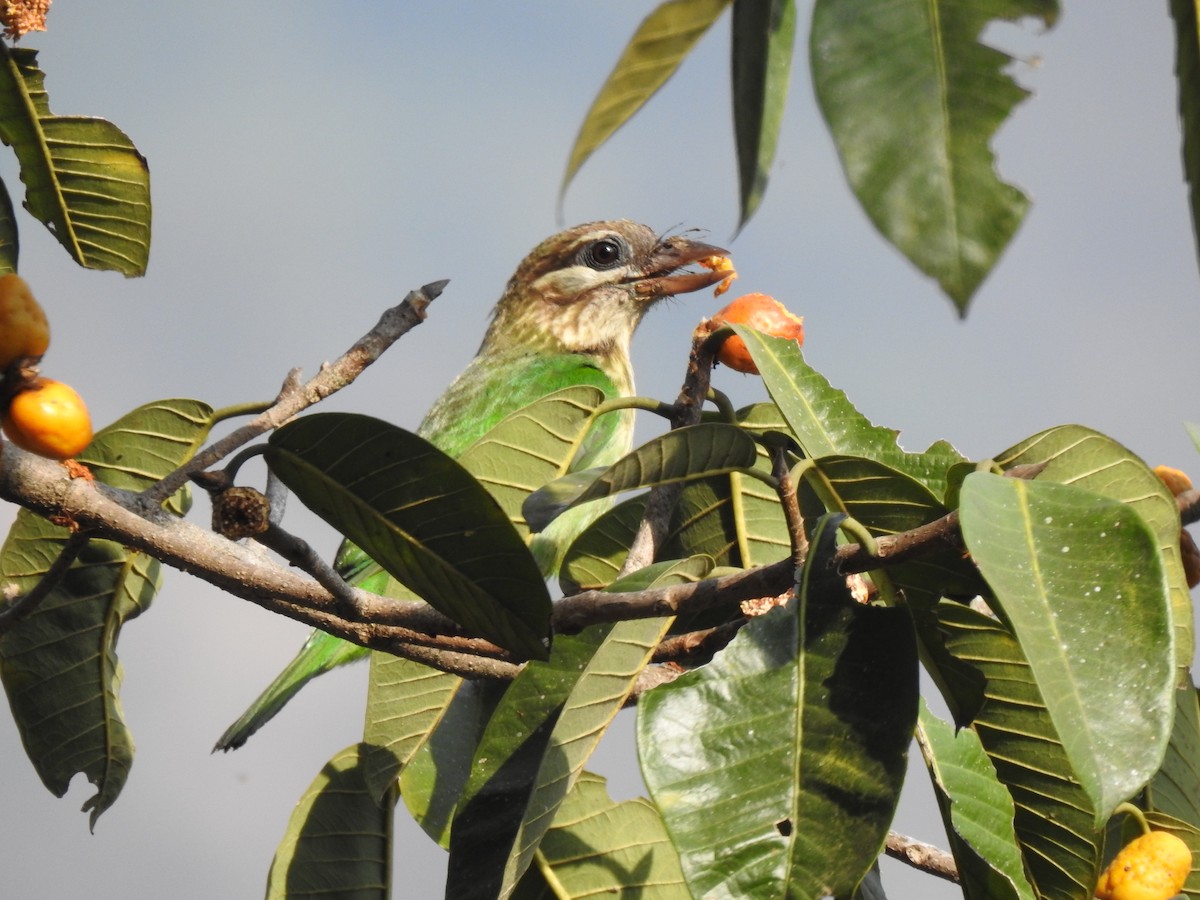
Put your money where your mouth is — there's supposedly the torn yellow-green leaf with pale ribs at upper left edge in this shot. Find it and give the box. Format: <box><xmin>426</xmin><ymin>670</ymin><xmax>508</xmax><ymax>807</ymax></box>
<box><xmin>0</xmin><ymin>47</ymin><xmax>150</xmax><ymax>276</ymax></box>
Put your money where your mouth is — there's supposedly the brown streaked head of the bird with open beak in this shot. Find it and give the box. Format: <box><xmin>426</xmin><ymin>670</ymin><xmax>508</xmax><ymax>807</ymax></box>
<box><xmin>484</xmin><ymin>220</ymin><xmax>726</xmax><ymax>358</ymax></box>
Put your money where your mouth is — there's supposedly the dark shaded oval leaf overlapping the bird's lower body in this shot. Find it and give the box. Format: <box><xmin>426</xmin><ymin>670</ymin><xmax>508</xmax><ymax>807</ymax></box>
<box><xmin>265</xmin><ymin>413</ymin><xmax>551</xmax><ymax>659</ymax></box>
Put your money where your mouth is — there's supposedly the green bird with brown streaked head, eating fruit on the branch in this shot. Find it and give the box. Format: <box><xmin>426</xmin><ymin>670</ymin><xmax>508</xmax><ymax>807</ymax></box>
<box><xmin>214</xmin><ymin>220</ymin><xmax>728</xmax><ymax>750</ymax></box>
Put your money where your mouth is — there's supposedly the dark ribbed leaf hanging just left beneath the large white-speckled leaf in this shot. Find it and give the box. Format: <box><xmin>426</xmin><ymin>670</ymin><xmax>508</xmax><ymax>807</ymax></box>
<box><xmin>937</xmin><ymin>600</ymin><xmax>1103</xmax><ymax>900</ymax></box>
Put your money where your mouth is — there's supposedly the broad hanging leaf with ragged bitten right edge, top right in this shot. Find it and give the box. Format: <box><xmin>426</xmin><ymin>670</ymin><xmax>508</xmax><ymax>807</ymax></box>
<box><xmin>810</xmin><ymin>0</ymin><xmax>1057</xmax><ymax>313</ymax></box>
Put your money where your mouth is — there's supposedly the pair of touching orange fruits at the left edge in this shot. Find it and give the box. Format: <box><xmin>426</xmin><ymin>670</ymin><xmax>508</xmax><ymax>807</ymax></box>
<box><xmin>0</xmin><ymin>275</ymin><xmax>91</xmax><ymax>460</ymax></box>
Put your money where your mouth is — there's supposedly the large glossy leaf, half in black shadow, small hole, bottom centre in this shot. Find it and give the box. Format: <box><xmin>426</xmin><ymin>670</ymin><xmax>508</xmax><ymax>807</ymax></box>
<box><xmin>637</xmin><ymin>518</ymin><xmax>917</xmax><ymax>896</ymax></box>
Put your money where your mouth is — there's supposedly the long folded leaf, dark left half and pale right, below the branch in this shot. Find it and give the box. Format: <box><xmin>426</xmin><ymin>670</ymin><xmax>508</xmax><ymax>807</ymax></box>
<box><xmin>446</xmin><ymin>559</ymin><xmax>712</xmax><ymax>898</ymax></box>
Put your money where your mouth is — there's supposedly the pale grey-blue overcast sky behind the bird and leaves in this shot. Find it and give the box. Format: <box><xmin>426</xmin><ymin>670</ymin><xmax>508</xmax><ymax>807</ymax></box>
<box><xmin>0</xmin><ymin>0</ymin><xmax>1200</xmax><ymax>900</ymax></box>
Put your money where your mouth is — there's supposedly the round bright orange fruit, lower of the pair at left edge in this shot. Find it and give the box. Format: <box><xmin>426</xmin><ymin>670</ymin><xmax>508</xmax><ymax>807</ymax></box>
<box><xmin>4</xmin><ymin>378</ymin><xmax>91</xmax><ymax>460</ymax></box>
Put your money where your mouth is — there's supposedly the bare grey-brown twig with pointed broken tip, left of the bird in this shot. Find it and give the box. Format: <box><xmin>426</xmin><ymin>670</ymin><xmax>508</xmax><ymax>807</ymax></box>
<box><xmin>142</xmin><ymin>281</ymin><xmax>449</xmax><ymax>509</ymax></box>
